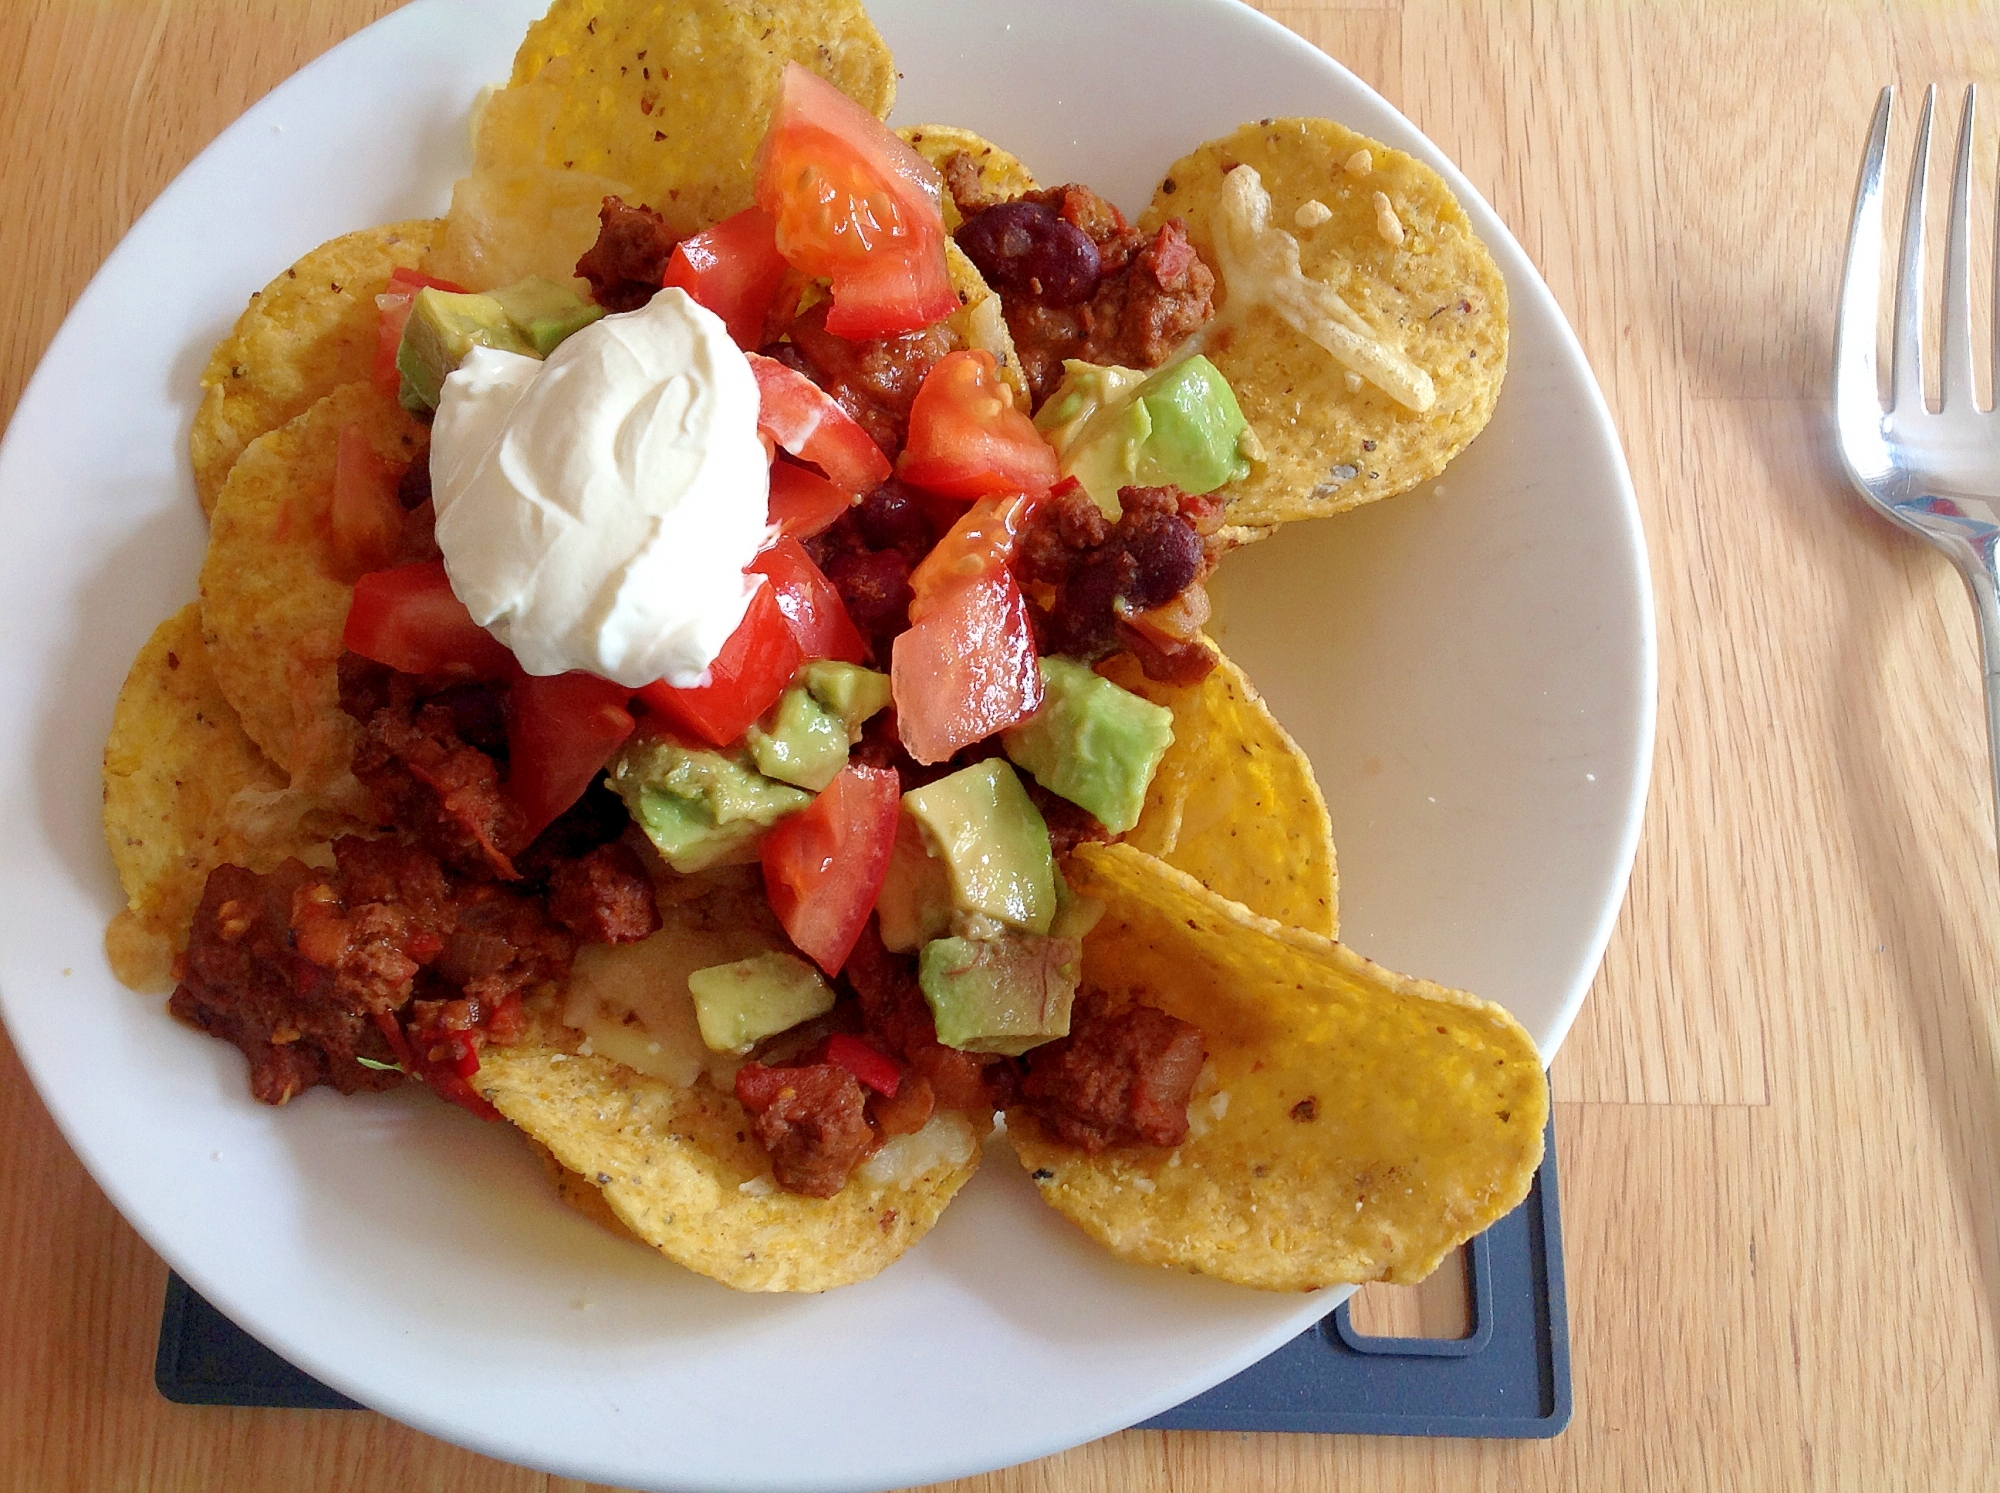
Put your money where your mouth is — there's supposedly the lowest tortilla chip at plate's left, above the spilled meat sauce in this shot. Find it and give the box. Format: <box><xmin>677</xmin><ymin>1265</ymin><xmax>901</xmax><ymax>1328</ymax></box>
<box><xmin>104</xmin><ymin>602</ymin><xmax>346</xmax><ymax>983</ymax></box>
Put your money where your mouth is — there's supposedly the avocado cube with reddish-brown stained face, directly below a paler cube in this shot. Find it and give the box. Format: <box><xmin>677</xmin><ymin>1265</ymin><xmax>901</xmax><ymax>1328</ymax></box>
<box><xmin>916</xmin><ymin>933</ymin><xmax>1084</xmax><ymax>1057</ymax></box>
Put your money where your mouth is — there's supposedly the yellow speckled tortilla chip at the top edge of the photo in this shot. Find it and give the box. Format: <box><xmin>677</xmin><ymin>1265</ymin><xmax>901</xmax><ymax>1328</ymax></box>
<box><xmin>494</xmin><ymin>0</ymin><xmax>896</xmax><ymax>234</ymax></box>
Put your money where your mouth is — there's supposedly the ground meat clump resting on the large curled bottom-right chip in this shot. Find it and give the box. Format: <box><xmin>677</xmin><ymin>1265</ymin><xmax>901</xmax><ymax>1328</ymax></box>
<box><xmin>1020</xmin><ymin>991</ymin><xmax>1206</xmax><ymax>1151</ymax></box>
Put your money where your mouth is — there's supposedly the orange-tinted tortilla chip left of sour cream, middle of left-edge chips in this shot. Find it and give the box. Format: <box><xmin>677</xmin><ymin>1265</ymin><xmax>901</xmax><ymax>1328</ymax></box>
<box><xmin>202</xmin><ymin>382</ymin><xmax>426</xmax><ymax>796</ymax></box>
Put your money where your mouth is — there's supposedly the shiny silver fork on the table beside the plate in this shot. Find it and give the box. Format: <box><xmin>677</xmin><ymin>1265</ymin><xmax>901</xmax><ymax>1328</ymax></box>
<box><xmin>1834</xmin><ymin>84</ymin><xmax>2000</xmax><ymax>856</ymax></box>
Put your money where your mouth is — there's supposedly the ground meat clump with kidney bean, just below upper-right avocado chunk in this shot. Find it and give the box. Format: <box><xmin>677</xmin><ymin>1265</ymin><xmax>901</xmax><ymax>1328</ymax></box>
<box><xmin>1014</xmin><ymin>486</ymin><xmax>1222</xmax><ymax>684</ymax></box>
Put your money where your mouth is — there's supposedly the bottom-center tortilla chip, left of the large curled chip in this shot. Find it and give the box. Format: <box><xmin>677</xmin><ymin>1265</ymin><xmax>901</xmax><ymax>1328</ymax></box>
<box><xmin>484</xmin><ymin>1012</ymin><xmax>980</xmax><ymax>1291</ymax></box>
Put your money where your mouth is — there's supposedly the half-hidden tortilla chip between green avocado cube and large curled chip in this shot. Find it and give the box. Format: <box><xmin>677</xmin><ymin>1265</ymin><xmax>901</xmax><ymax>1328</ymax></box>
<box><xmin>1100</xmin><ymin>652</ymin><xmax>1340</xmax><ymax>939</ymax></box>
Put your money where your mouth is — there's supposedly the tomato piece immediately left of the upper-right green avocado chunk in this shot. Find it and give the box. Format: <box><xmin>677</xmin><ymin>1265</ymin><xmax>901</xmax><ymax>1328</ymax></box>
<box><xmin>896</xmin><ymin>348</ymin><xmax>1060</xmax><ymax>498</ymax></box>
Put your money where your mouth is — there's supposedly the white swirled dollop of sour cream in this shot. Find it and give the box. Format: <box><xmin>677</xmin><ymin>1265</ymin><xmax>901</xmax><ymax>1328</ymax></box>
<box><xmin>430</xmin><ymin>290</ymin><xmax>770</xmax><ymax>688</ymax></box>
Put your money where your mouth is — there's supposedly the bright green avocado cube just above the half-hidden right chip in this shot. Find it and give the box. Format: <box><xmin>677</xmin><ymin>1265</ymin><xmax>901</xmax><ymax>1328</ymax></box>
<box><xmin>1000</xmin><ymin>658</ymin><xmax>1174</xmax><ymax>835</ymax></box>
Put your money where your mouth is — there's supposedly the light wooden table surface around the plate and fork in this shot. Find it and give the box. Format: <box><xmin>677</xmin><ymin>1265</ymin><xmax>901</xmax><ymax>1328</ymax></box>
<box><xmin>0</xmin><ymin>0</ymin><xmax>2000</xmax><ymax>1493</ymax></box>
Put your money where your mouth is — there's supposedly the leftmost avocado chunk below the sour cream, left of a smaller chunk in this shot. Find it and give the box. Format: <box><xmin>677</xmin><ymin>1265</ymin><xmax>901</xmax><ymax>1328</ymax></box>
<box><xmin>610</xmin><ymin>732</ymin><xmax>812</xmax><ymax>873</ymax></box>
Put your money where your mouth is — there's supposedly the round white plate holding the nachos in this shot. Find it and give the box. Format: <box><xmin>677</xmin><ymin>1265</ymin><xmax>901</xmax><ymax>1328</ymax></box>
<box><xmin>0</xmin><ymin>0</ymin><xmax>1654</xmax><ymax>1493</ymax></box>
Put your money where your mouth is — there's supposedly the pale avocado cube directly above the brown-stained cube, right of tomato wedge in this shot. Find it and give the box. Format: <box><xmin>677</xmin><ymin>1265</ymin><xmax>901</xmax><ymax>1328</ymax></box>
<box><xmin>902</xmin><ymin>757</ymin><xmax>1056</xmax><ymax>933</ymax></box>
